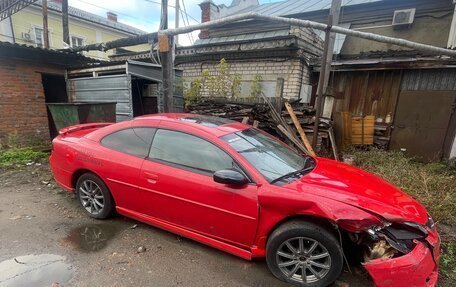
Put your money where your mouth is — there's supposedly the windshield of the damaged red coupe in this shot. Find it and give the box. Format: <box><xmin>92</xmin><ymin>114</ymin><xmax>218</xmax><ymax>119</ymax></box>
<box><xmin>222</xmin><ymin>129</ymin><xmax>309</xmax><ymax>183</ymax></box>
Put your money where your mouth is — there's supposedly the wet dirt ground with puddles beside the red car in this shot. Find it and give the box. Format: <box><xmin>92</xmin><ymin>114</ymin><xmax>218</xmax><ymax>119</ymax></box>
<box><xmin>0</xmin><ymin>164</ymin><xmax>370</xmax><ymax>287</ymax></box>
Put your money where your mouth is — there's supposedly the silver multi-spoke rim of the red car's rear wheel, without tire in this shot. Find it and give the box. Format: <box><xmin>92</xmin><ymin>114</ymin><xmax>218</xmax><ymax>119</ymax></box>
<box><xmin>79</xmin><ymin>179</ymin><xmax>105</xmax><ymax>215</ymax></box>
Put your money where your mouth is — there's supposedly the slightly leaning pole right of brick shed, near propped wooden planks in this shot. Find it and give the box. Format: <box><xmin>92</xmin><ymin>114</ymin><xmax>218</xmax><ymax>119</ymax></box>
<box><xmin>312</xmin><ymin>0</ymin><xmax>342</xmax><ymax>148</ymax></box>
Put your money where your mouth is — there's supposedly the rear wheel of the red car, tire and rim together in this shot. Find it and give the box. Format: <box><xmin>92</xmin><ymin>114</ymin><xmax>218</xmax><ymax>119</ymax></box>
<box><xmin>76</xmin><ymin>173</ymin><xmax>115</xmax><ymax>219</ymax></box>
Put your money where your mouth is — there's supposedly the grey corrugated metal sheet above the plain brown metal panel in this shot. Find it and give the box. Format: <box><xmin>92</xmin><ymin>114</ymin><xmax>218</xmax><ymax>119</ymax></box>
<box><xmin>401</xmin><ymin>69</ymin><xmax>456</xmax><ymax>91</ymax></box>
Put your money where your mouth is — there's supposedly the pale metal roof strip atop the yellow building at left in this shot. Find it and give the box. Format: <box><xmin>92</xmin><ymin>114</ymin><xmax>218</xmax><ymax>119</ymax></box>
<box><xmin>32</xmin><ymin>0</ymin><xmax>146</xmax><ymax>35</ymax></box>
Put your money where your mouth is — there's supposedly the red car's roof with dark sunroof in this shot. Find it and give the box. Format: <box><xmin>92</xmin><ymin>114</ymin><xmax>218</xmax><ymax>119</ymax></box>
<box><xmin>133</xmin><ymin>113</ymin><xmax>250</xmax><ymax>137</ymax></box>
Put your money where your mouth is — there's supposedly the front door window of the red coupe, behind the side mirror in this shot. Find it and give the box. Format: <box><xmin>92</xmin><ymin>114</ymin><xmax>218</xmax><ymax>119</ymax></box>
<box><xmin>149</xmin><ymin>130</ymin><xmax>237</xmax><ymax>173</ymax></box>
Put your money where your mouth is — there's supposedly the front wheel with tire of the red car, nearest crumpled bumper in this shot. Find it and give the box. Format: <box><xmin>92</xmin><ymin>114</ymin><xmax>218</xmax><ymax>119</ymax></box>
<box><xmin>266</xmin><ymin>220</ymin><xmax>343</xmax><ymax>287</ymax></box>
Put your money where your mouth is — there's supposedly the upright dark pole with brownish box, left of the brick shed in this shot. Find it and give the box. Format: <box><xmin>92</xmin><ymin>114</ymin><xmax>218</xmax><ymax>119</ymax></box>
<box><xmin>158</xmin><ymin>0</ymin><xmax>174</xmax><ymax>113</ymax></box>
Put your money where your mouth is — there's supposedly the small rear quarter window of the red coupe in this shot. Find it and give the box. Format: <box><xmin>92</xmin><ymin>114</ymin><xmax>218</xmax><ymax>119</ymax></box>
<box><xmin>101</xmin><ymin>128</ymin><xmax>156</xmax><ymax>158</ymax></box>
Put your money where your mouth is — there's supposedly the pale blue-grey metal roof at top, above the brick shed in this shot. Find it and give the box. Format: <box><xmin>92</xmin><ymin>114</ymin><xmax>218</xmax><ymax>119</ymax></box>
<box><xmin>236</xmin><ymin>0</ymin><xmax>383</xmax><ymax>16</ymax></box>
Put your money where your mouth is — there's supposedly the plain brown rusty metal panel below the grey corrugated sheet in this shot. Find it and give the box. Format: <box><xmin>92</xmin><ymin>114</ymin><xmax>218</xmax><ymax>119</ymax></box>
<box><xmin>390</xmin><ymin>91</ymin><xmax>456</xmax><ymax>160</ymax></box>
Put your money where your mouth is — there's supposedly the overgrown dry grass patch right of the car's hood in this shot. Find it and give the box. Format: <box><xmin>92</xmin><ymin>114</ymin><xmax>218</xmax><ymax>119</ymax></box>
<box><xmin>349</xmin><ymin>149</ymin><xmax>456</xmax><ymax>287</ymax></box>
